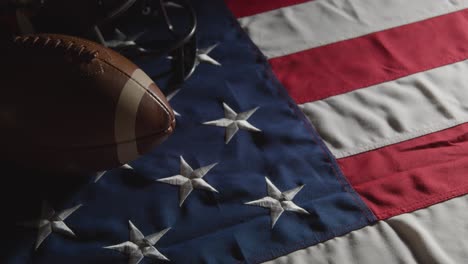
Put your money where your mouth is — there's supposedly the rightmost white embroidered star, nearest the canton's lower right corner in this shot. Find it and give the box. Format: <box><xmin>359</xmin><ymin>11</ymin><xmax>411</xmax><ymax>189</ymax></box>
<box><xmin>245</xmin><ymin>177</ymin><xmax>310</xmax><ymax>228</ymax></box>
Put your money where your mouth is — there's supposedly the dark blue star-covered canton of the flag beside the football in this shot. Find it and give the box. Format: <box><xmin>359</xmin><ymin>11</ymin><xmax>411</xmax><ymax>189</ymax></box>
<box><xmin>2</xmin><ymin>0</ymin><xmax>375</xmax><ymax>264</ymax></box>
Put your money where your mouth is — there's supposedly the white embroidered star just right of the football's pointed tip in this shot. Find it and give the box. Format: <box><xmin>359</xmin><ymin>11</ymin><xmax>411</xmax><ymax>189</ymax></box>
<box><xmin>203</xmin><ymin>103</ymin><xmax>261</xmax><ymax>144</ymax></box>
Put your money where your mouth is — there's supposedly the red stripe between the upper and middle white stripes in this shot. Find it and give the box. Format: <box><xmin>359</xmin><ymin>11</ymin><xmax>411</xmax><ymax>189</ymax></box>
<box><xmin>270</xmin><ymin>10</ymin><xmax>468</xmax><ymax>104</ymax></box>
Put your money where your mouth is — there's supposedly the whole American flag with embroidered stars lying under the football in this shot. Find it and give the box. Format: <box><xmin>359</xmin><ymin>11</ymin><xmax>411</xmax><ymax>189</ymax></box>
<box><xmin>0</xmin><ymin>0</ymin><xmax>468</xmax><ymax>264</ymax></box>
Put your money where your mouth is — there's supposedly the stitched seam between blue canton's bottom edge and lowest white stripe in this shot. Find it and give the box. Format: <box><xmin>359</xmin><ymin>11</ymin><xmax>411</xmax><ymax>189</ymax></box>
<box><xmin>247</xmin><ymin>217</ymin><xmax>365</xmax><ymax>263</ymax></box>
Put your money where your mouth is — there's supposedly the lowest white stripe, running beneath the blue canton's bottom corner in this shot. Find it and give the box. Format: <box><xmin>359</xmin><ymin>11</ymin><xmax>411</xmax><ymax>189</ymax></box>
<box><xmin>266</xmin><ymin>195</ymin><xmax>468</xmax><ymax>264</ymax></box>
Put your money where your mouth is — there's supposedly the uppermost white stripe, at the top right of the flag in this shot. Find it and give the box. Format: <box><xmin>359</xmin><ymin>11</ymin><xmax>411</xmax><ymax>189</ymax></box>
<box><xmin>239</xmin><ymin>0</ymin><xmax>468</xmax><ymax>58</ymax></box>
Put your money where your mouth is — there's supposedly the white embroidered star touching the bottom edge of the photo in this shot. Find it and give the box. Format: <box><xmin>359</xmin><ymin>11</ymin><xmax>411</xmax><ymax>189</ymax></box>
<box><xmin>104</xmin><ymin>221</ymin><xmax>171</xmax><ymax>264</ymax></box>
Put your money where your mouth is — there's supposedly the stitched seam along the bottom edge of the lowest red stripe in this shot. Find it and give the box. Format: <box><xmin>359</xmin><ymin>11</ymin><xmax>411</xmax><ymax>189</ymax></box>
<box><xmin>376</xmin><ymin>184</ymin><xmax>468</xmax><ymax>220</ymax></box>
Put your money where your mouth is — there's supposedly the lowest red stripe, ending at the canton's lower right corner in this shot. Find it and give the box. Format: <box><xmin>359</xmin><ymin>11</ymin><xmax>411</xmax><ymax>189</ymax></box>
<box><xmin>338</xmin><ymin>124</ymin><xmax>468</xmax><ymax>219</ymax></box>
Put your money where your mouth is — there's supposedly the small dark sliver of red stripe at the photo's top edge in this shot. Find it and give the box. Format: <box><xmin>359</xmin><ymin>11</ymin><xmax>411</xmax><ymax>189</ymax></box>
<box><xmin>225</xmin><ymin>0</ymin><xmax>310</xmax><ymax>18</ymax></box>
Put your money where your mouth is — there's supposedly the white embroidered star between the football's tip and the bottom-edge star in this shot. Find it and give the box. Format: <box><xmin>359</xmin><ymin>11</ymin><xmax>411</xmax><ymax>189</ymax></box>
<box><xmin>156</xmin><ymin>156</ymin><xmax>218</xmax><ymax>206</ymax></box>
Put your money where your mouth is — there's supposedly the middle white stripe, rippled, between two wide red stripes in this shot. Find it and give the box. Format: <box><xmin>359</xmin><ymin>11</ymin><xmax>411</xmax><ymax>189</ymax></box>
<box><xmin>300</xmin><ymin>60</ymin><xmax>468</xmax><ymax>158</ymax></box>
